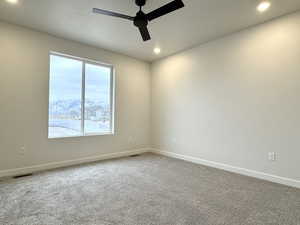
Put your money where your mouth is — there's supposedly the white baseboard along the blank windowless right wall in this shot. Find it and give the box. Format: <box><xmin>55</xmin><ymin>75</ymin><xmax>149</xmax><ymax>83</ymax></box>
<box><xmin>151</xmin><ymin>149</ymin><xmax>300</xmax><ymax>188</ymax></box>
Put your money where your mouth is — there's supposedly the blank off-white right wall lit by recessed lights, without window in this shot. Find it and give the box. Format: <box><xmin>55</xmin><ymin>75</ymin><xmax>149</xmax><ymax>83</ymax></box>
<box><xmin>151</xmin><ymin>13</ymin><xmax>300</xmax><ymax>180</ymax></box>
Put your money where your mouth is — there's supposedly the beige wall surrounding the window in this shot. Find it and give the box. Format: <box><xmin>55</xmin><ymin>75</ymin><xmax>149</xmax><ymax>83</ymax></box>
<box><xmin>0</xmin><ymin>23</ymin><xmax>151</xmax><ymax>171</ymax></box>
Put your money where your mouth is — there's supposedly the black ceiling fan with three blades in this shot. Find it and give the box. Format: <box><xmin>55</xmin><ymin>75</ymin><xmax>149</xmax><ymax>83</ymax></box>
<box><xmin>93</xmin><ymin>0</ymin><xmax>184</xmax><ymax>41</ymax></box>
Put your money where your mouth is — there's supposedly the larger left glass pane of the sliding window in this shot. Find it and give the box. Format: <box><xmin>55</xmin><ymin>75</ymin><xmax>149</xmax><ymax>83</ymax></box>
<box><xmin>48</xmin><ymin>55</ymin><xmax>82</xmax><ymax>138</ymax></box>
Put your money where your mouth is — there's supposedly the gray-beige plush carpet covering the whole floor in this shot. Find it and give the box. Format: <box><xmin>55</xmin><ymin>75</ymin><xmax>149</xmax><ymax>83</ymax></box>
<box><xmin>0</xmin><ymin>154</ymin><xmax>300</xmax><ymax>225</ymax></box>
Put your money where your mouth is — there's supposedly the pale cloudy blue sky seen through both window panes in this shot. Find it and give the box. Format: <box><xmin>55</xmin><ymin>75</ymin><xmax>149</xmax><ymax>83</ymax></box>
<box><xmin>50</xmin><ymin>55</ymin><xmax>110</xmax><ymax>104</ymax></box>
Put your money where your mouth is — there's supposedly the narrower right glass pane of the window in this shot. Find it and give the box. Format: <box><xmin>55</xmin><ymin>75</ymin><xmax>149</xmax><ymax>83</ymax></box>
<box><xmin>84</xmin><ymin>63</ymin><xmax>111</xmax><ymax>133</ymax></box>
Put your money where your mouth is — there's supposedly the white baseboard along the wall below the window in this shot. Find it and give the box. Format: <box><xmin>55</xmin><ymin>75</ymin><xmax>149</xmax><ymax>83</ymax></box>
<box><xmin>0</xmin><ymin>148</ymin><xmax>149</xmax><ymax>178</ymax></box>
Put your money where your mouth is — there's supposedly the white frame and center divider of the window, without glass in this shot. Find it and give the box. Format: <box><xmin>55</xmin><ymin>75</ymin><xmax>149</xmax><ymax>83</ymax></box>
<box><xmin>47</xmin><ymin>51</ymin><xmax>115</xmax><ymax>139</ymax></box>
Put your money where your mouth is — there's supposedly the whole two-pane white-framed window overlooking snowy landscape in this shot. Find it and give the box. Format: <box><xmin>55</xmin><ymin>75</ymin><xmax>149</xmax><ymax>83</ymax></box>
<box><xmin>48</xmin><ymin>53</ymin><xmax>113</xmax><ymax>138</ymax></box>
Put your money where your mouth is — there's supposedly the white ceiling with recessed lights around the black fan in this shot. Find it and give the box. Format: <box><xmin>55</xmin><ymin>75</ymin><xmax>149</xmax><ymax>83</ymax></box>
<box><xmin>0</xmin><ymin>0</ymin><xmax>300</xmax><ymax>61</ymax></box>
